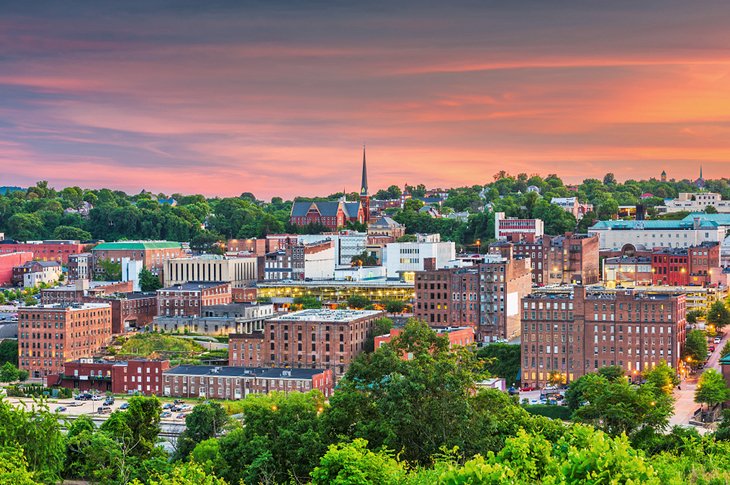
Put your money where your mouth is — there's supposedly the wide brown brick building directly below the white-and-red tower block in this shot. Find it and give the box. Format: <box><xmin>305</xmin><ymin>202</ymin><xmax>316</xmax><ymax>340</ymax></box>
<box><xmin>489</xmin><ymin>233</ymin><xmax>601</xmax><ymax>286</ymax></box>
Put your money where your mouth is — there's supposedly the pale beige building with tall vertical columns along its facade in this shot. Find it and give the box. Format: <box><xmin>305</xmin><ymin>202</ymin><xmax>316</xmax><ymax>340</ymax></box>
<box><xmin>163</xmin><ymin>254</ymin><xmax>258</xmax><ymax>288</ymax></box>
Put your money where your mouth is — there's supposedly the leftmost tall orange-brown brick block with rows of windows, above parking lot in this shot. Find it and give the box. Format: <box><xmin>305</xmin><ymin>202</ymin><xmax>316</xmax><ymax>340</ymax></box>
<box><xmin>18</xmin><ymin>303</ymin><xmax>112</xmax><ymax>377</ymax></box>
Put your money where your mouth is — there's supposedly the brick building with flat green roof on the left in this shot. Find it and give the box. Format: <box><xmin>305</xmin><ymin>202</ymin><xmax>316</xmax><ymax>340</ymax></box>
<box><xmin>91</xmin><ymin>241</ymin><xmax>187</xmax><ymax>275</ymax></box>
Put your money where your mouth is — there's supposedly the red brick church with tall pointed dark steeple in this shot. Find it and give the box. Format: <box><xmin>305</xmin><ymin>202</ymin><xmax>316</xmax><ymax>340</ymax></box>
<box><xmin>289</xmin><ymin>147</ymin><xmax>370</xmax><ymax>231</ymax></box>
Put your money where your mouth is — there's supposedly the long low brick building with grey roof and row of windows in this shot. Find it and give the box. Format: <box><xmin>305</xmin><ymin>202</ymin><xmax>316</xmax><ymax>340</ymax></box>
<box><xmin>162</xmin><ymin>365</ymin><xmax>335</xmax><ymax>399</ymax></box>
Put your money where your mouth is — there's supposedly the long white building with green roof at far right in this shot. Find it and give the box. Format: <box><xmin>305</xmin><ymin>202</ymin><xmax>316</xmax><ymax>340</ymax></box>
<box><xmin>588</xmin><ymin>217</ymin><xmax>726</xmax><ymax>250</ymax></box>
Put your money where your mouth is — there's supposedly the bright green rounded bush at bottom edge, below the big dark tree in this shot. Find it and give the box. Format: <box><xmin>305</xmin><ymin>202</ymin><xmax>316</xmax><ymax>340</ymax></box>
<box><xmin>312</xmin><ymin>439</ymin><xmax>406</xmax><ymax>485</ymax></box>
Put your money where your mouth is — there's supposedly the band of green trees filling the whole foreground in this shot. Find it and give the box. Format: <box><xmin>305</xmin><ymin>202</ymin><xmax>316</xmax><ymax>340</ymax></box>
<box><xmin>0</xmin><ymin>321</ymin><xmax>730</xmax><ymax>485</ymax></box>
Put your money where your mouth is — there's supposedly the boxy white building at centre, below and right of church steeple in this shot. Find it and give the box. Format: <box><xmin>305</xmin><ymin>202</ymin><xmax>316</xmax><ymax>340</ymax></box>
<box><xmin>383</xmin><ymin>235</ymin><xmax>456</xmax><ymax>281</ymax></box>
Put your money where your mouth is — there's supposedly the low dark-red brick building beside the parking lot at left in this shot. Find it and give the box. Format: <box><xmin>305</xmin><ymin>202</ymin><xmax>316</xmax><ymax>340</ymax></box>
<box><xmin>46</xmin><ymin>359</ymin><xmax>170</xmax><ymax>396</ymax></box>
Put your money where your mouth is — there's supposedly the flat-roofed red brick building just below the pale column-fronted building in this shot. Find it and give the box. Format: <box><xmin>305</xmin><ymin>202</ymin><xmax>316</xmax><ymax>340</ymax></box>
<box><xmin>157</xmin><ymin>281</ymin><xmax>231</xmax><ymax>316</ymax></box>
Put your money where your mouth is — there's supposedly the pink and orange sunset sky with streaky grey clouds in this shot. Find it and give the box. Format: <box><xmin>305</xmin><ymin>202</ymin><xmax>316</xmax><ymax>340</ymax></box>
<box><xmin>0</xmin><ymin>0</ymin><xmax>730</xmax><ymax>198</ymax></box>
